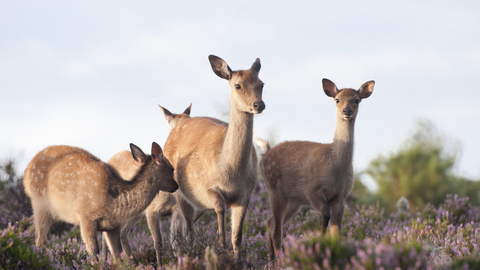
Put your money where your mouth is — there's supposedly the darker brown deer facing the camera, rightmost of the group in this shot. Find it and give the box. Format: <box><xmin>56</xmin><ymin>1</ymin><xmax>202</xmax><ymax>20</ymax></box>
<box><xmin>255</xmin><ymin>79</ymin><xmax>375</xmax><ymax>261</ymax></box>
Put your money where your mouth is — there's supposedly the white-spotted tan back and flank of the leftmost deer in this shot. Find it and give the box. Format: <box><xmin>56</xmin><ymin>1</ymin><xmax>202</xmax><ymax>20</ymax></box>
<box><xmin>24</xmin><ymin>146</ymin><xmax>113</xmax><ymax>223</ymax></box>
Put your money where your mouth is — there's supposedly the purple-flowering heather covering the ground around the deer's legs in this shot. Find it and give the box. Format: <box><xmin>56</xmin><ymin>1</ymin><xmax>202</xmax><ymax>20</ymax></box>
<box><xmin>0</xmin><ymin>170</ymin><xmax>480</xmax><ymax>269</ymax></box>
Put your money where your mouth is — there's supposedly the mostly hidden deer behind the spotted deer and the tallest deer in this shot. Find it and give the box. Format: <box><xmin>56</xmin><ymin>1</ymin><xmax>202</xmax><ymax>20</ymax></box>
<box><xmin>102</xmin><ymin>103</ymin><xmax>192</xmax><ymax>265</ymax></box>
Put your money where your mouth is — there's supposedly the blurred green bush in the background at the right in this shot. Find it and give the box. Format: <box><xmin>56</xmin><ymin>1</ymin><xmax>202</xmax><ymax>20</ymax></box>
<box><xmin>364</xmin><ymin>121</ymin><xmax>480</xmax><ymax>211</ymax></box>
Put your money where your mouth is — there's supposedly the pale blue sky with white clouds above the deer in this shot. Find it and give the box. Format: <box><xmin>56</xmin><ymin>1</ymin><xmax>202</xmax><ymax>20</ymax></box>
<box><xmin>0</xmin><ymin>0</ymin><xmax>480</xmax><ymax>189</ymax></box>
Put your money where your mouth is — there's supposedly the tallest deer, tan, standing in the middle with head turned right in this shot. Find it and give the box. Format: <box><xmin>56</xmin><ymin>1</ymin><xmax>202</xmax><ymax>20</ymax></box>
<box><xmin>165</xmin><ymin>55</ymin><xmax>265</xmax><ymax>254</ymax></box>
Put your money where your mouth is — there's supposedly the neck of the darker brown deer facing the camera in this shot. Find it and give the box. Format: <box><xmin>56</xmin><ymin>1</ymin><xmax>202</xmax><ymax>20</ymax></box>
<box><xmin>333</xmin><ymin>117</ymin><xmax>355</xmax><ymax>168</ymax></box>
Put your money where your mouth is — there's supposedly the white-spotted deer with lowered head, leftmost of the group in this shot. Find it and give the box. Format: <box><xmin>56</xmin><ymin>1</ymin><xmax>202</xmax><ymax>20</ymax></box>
<box><xmin>23</xmin><ymin>142</ymin><xmax>178</xmax><ymax>261</ymax></box>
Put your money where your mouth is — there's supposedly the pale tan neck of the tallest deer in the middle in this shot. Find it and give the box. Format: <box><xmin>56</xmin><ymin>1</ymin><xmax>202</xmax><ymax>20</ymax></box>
<box><xmin>219</xmin><ymin>108</ymin><xmax>253</xmax><ymax>173</ymax></box>
